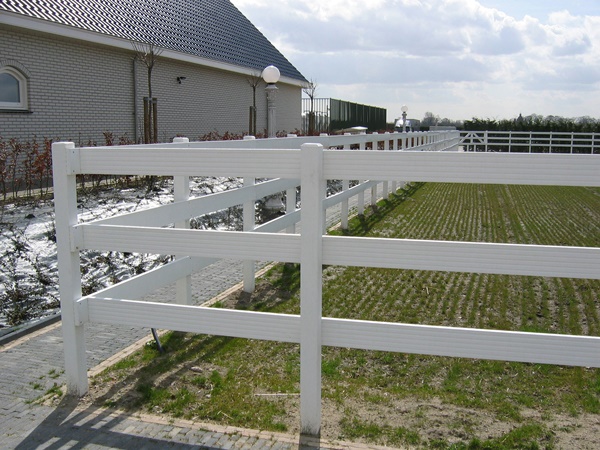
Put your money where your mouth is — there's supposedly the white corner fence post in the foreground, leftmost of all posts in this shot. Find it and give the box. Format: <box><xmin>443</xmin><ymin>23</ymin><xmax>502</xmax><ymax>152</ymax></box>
<box><xmin>52</xmin><ymin>142</ymin><xmax>88</xmax><ymax>396</ymax></box>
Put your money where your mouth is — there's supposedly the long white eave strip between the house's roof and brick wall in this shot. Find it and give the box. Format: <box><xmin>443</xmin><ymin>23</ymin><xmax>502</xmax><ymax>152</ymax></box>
<box><xmin>0</xmin><ymin>12</ymin><xmax>305</xmax><ymax>87</ymax></box>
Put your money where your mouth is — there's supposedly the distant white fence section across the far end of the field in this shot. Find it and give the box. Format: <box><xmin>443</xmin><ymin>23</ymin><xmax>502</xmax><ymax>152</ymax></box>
<box><xmin>460</xmin><ymin>131</ymin><xmax>600</xmax><ymax>154</ymax></box>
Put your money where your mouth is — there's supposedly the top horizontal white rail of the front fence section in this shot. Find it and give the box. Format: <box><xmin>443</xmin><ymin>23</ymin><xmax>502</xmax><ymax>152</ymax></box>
<box><xmin>65</xmin><ymin>148</ymin><xmax>600</xmax><ymax>185</ymax></box>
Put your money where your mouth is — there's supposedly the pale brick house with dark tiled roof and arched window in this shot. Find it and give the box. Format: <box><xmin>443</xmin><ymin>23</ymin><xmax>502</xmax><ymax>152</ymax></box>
<box><xmin>0</xmin><ymin>0</ymin><xmax>306</xmax><ymax>145</ymax></box>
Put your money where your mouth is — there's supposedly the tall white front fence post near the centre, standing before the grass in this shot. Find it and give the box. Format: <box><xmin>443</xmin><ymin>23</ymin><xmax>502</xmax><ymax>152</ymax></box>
<box><xmin>300</xmin><ymin>144</ymin><xmax>325</xmax><ymax>436</ymax></box>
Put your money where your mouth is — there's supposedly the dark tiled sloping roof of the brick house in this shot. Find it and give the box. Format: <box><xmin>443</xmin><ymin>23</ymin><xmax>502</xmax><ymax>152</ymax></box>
<box><xmin>0</xmin><ymin>0</ymin><xmax>306</xmax><ymax>81</ymax></box>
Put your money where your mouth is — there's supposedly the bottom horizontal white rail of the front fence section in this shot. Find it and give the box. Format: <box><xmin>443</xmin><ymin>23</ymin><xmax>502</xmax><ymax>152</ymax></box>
<box><xmin>80</xmin><ymin>297</ymin><xmax>600</xmax><ymax>367</ymax></box>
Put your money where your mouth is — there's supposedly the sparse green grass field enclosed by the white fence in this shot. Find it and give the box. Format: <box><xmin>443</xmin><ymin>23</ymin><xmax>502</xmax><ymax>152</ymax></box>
<box><xmin>93</xmin><ymin>183</ymin><xmax>600</xmax><ymax>449</ymax></box>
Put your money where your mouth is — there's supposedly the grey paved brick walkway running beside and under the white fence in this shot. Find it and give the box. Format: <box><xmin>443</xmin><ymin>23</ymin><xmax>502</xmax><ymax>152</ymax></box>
<box><xmin>0</xmin><ymin>185</ymin><xmax>398</xmax><ymax>450</ymax></box>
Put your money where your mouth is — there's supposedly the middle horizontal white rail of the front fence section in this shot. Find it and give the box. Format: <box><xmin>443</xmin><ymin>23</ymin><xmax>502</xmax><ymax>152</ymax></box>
<box><xmin>75</xmin><ymin>229</ymin><xmax>600</xmax><ymax>278</ymax></box>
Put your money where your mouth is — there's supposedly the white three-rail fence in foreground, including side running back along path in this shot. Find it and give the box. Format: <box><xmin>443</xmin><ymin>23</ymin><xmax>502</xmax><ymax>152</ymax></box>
<box><xmin>53</xmin><ymin>132</ymin><xmax>600</xmax><ymax>435</ymax></box>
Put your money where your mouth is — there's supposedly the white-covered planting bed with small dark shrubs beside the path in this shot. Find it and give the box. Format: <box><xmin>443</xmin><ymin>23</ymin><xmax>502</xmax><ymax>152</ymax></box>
<box><xmin>0</xmin><ymin>177</ymin><xmax>248</xmax><ymax>328</ymax></box>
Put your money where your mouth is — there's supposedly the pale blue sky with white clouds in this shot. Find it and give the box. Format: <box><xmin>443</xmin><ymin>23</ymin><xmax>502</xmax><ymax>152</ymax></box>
<box><xmin>231</xmin><ymin>0</ymin><xmax>600</xmax><ymax>121</ymax></box>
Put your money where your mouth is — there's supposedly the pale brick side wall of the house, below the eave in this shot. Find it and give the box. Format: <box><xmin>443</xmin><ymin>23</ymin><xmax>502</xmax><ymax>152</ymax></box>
<box><xmin>0</xmin><ymin>25</ymin><xmax>301</xmax><ymax>145</ymax></box>
